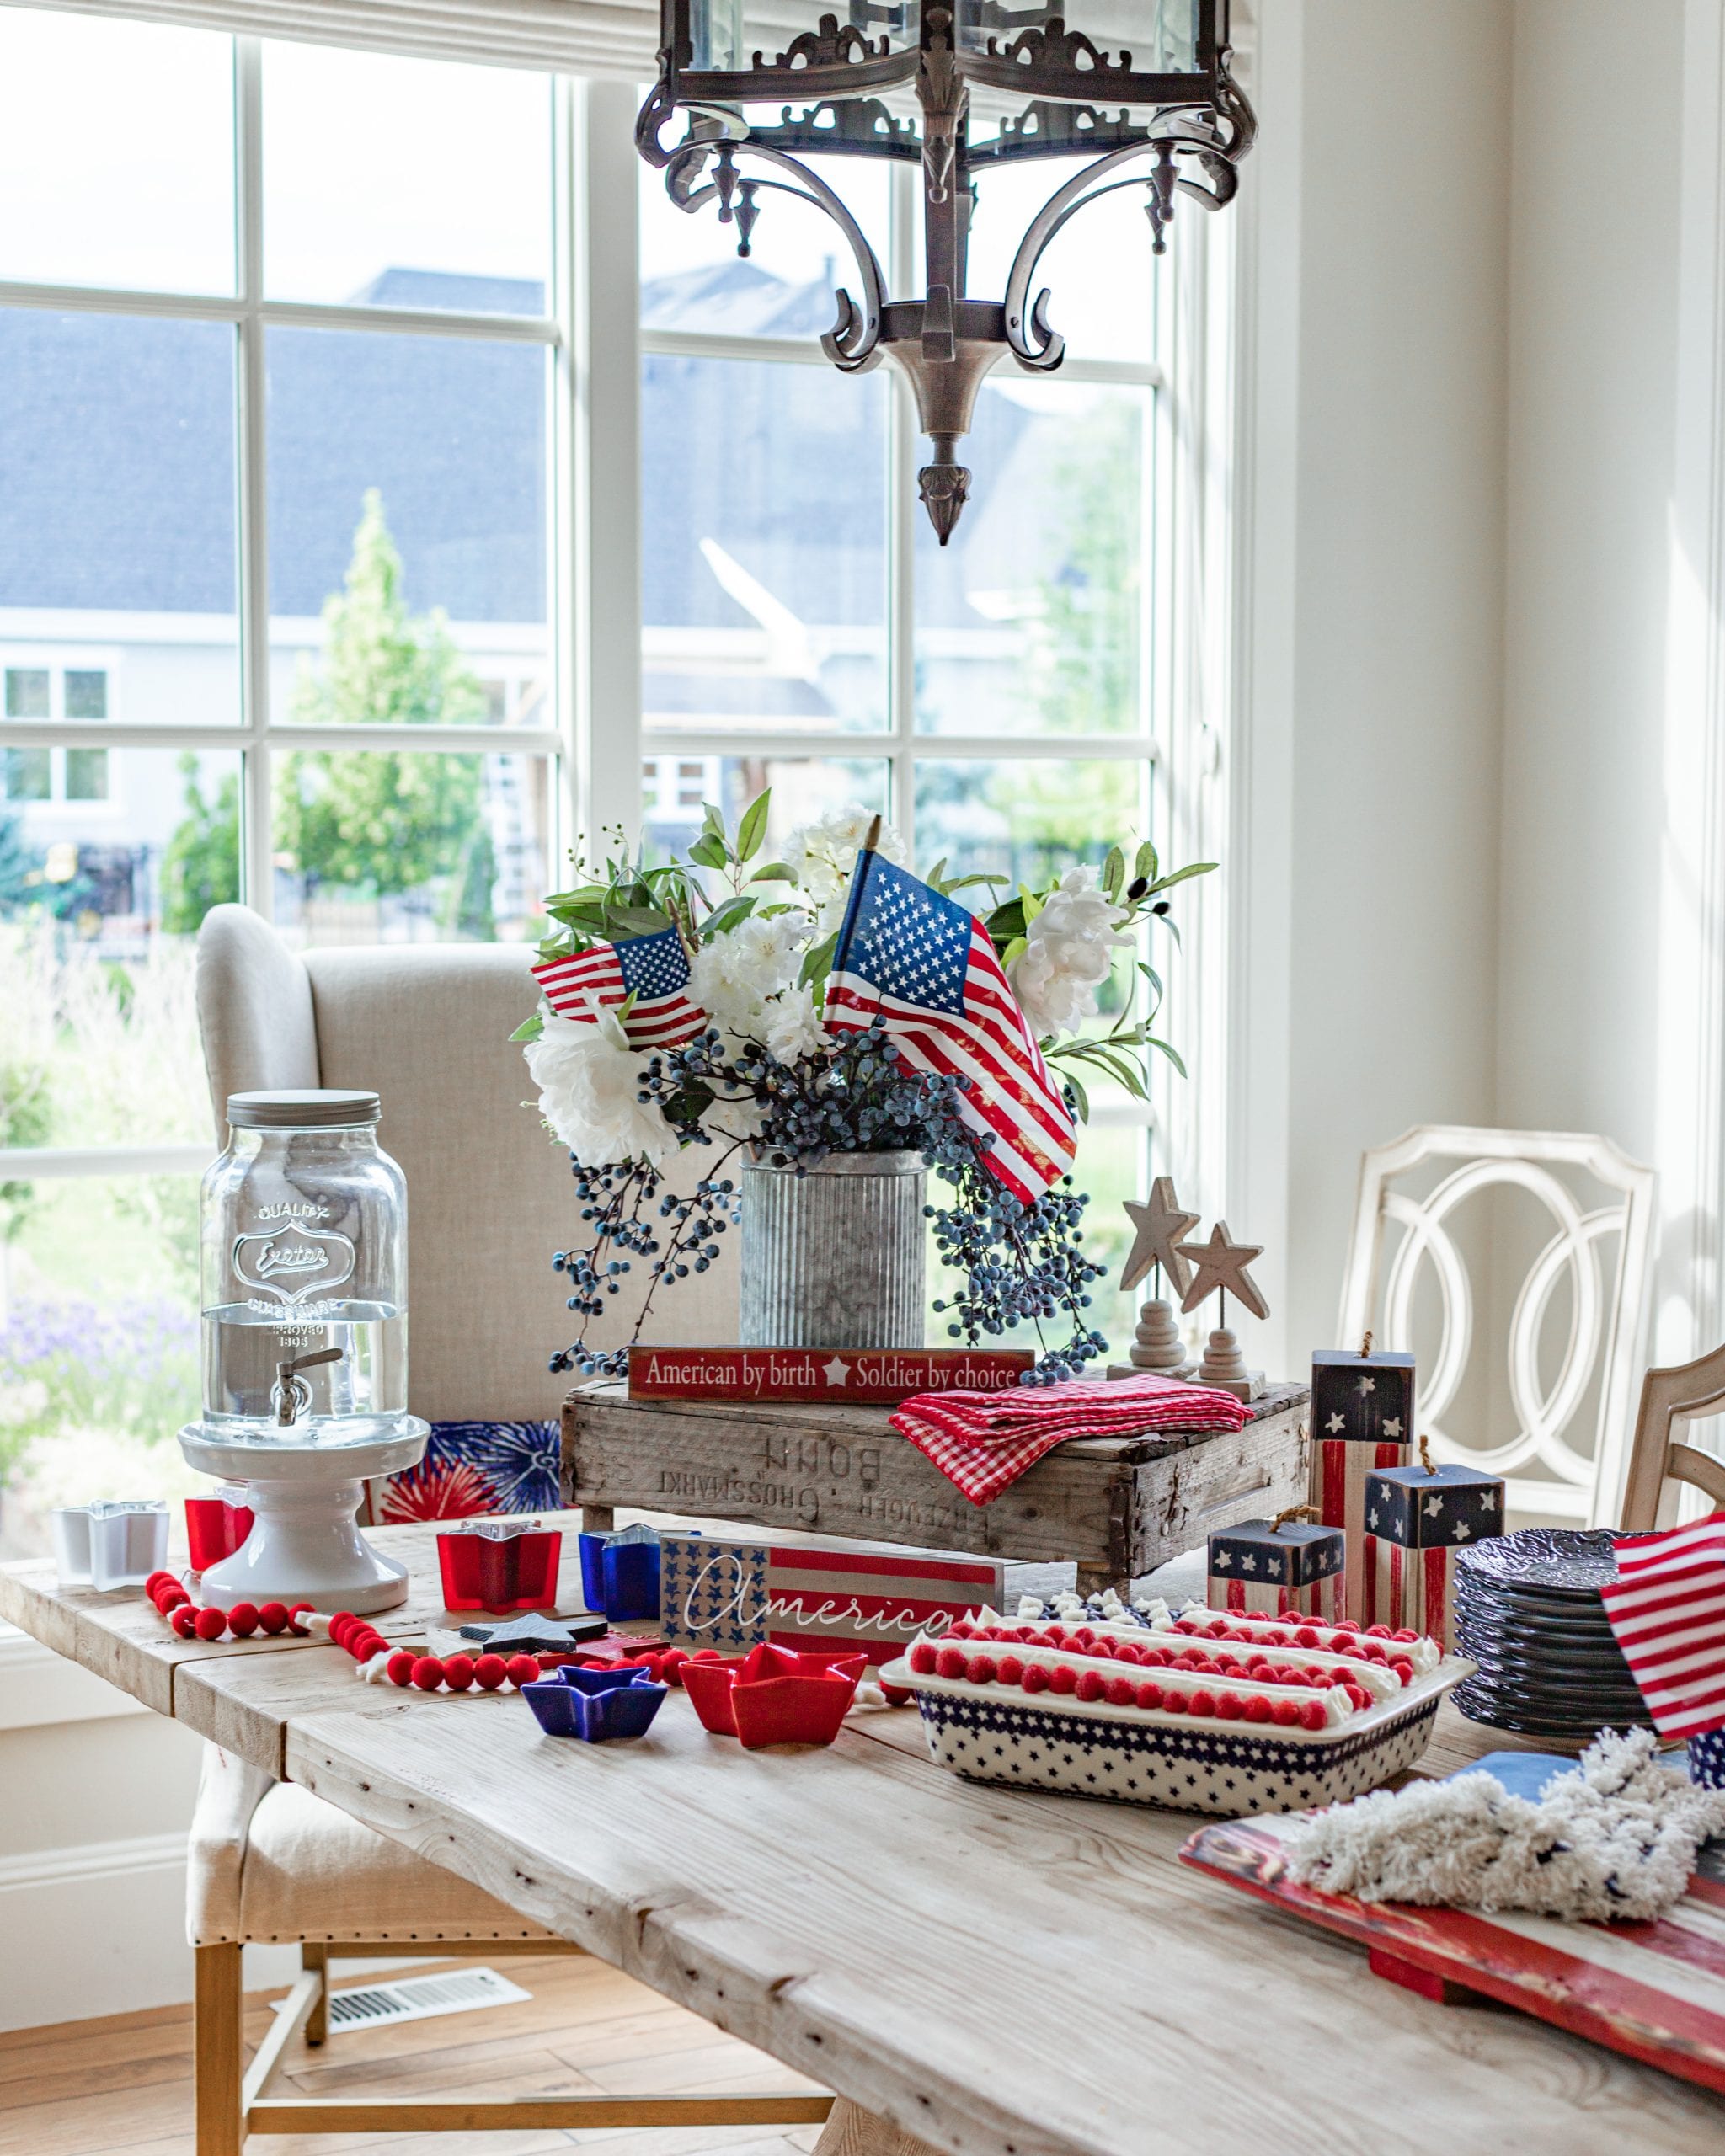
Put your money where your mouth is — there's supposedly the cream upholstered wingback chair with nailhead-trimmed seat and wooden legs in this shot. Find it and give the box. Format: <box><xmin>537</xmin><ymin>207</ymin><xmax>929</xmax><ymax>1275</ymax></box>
<box><xmin>188</xmin><ymin>905</ymin><xmax>784</xmax><ymax>2156</ymax></box>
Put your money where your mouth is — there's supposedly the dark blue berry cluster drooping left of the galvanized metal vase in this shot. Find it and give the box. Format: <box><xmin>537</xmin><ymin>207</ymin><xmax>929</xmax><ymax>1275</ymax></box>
<box><xmin>550</xmin><ymin>1132</ymin><xmax>742</xmax><ymax>1378</ymax></box>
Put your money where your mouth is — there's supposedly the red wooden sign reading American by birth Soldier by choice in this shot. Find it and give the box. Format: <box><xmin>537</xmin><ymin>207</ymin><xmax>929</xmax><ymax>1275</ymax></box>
<box><xmin>630</xmin><ymin>1348</ymin><xmax>1035</xmax><ymax>1408</ymax></box>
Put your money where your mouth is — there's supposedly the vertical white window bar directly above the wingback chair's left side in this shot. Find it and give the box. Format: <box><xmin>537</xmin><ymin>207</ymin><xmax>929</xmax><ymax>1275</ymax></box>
<box><xmin>232</xmin><ymin>37</ymin><xmax>276</xmax><ymax>921</ymax></box>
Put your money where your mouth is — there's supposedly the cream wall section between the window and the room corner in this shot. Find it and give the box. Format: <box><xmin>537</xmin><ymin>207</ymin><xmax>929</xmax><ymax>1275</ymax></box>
<box><xmin>1229</xmin><ymin>0</ymin><xmax>1512</xmax><ymax>1369</ymax></box>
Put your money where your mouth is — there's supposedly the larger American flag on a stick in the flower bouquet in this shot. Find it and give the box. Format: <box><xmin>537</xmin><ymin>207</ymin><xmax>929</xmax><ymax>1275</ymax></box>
<box><xmin>825</xmin><ymin>850</ymin><xmax>1078</xmax><ymax>1205</ymax></box>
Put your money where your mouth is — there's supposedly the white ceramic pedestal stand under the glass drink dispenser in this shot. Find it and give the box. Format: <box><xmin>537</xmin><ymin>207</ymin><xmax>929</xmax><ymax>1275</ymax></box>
<box><xmin>179</xmin><ymin>1417</ymin><xmax>431</xmax><ymax>1614</ymax></box>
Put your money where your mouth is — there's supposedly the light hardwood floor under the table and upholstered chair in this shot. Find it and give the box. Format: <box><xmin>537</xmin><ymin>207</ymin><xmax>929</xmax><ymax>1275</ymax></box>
<box><xmin>0</xmin><ymin>1957</ymin><xmax>820</xmax><ymax>2156</ymax></box>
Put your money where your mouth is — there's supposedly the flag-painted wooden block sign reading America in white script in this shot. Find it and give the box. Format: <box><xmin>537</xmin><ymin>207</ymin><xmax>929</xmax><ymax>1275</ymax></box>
<box><xmin>660</xmin><ymin>1529</ymin><xmax>1076</xmax><ymax>1664</ymax></box>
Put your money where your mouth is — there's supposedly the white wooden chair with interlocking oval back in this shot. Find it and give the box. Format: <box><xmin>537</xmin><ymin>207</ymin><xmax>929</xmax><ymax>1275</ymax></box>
<box><xmin>1339</xmin><ymin>1123</ymin><xmax>1656</xmax><ymax>1526</ymax></box>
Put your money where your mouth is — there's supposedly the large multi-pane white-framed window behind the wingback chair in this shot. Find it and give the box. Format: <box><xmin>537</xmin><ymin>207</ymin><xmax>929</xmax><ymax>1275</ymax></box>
<box><xmin>0</xmin><ymin>7</ymin><xmax>1215</xmax><ymax>1548</ymax></box>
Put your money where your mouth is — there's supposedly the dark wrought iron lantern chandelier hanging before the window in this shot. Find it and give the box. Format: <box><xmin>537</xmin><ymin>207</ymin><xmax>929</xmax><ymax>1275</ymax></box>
<box><xmin>636</xmin><ymin>0</ymin><xmax>1257</xmax><ymax>546</ymax></box>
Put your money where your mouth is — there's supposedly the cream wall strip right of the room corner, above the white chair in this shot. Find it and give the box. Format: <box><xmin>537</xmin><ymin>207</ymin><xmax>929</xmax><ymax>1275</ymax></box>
<box><xmin>1497</xmin><ymin>0</ymin><xmax>1684</xmax><ymax>1160</ymax></box>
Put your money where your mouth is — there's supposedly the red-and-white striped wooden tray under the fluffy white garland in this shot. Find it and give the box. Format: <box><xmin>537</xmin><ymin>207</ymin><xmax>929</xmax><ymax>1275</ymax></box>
<box><xmin>1179</xmin><ymin>1820</ymin><xmax>1725</xmax><ymax>2091</ymax></box>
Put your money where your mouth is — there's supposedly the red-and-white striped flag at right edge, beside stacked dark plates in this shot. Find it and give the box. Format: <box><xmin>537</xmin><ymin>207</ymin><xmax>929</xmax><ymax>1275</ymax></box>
<box><xmin>1600</xmin><ymin>1512</ymin><xmax>1725</xmax><ymax>1737</ymax></box>
